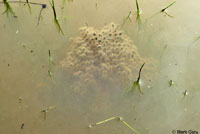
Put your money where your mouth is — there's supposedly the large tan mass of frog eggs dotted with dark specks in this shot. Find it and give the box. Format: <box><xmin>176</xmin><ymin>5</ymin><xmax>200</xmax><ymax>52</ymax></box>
<box><xmin>61</xmin><ymin>23</ymin><xmax>150</xmax><ymax>88</ymax></box>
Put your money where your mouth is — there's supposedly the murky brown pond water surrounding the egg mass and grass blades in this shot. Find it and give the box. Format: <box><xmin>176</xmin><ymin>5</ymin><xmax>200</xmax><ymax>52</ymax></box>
<box><xmin>0</xmin><ymin>0</ymin><xmax>200</xmax><ymax>134</ymax></box>
